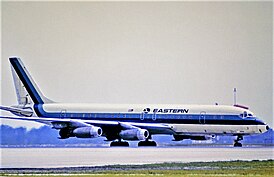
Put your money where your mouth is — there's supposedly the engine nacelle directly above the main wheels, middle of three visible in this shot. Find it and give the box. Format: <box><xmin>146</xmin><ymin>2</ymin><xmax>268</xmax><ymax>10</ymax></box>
<box><xmin>119</xmin><ymin>128</ymin><xmax>149</xmax><ymax>140</ymax></box>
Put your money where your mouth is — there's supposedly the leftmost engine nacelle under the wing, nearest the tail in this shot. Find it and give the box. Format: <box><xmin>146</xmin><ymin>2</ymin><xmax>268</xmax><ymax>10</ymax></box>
<box><xmin>72</xmin><ymin>126</ymin><xmax>103</xmax><ymax>138</ymax></box>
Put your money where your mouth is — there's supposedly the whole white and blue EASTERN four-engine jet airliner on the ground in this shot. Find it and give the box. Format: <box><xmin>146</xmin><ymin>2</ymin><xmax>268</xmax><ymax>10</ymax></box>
<box><xmin>0</xmin><ymin>57</ymin><xmax>269</xmax><ymax>147</ymax></box>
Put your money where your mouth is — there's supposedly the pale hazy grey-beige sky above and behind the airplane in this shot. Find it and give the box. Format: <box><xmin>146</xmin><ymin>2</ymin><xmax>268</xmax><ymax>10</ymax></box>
<box><xmin>0</xmin><ymin>2</ymin><xmax>273</xmax><ymax>127</ymax></box>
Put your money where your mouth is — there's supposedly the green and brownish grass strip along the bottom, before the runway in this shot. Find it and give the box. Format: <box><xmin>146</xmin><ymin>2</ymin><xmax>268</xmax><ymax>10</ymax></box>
<box><xmin>0</xmin><ymin>160</ymin><xmax>274</xmax><ymax>177</ymax></box>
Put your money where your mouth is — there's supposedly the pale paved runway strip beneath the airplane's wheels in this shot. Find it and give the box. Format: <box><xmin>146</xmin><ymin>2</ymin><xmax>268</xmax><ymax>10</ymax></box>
<box><xmin>1</xmin><ymin>147</ymin><xmax>274</xmax><ymax>168</ymax></box>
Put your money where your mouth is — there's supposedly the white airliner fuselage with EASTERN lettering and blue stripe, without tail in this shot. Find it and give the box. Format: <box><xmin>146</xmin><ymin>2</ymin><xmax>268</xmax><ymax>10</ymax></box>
<box><xmin>36</xmin><ymin>103</ymin><xmax>267</xmax><ymax>135</ymax></box>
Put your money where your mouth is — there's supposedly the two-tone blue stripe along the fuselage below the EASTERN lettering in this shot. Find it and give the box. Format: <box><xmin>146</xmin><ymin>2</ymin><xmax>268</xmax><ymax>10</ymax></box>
<box><xmin>36</xmin><ymin>104</ymin><xmax>264</xmax><ymax>125</ymax></box>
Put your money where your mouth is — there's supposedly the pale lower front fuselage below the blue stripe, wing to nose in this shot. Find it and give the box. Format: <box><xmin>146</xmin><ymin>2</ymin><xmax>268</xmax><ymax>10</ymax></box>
<box><xmin>170</xmin><ymin>124</ymin><xmax>266</xmax><ymax>134</ymax></box>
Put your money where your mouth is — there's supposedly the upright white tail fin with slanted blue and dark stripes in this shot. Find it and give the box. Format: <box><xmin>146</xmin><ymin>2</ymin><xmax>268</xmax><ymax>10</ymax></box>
<box><xmin>9</xmin><ymin>57</ymin><xmax>53</xmax><ymax>104</ymax></box>
